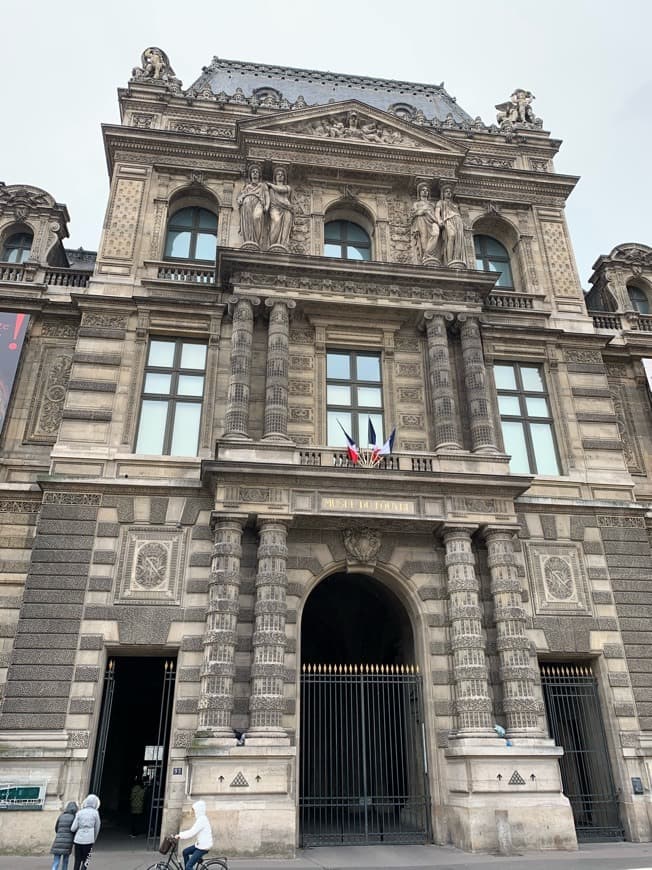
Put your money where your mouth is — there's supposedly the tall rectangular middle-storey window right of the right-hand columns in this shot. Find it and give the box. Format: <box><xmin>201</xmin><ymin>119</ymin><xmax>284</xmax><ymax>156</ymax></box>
<box><xmin>494</xmin><ymin>363</ymin><xmax>560</xmax><ymax>474</ymax></box>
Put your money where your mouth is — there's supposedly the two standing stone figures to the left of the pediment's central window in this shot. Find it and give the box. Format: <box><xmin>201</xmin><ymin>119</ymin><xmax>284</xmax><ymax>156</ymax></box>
<box><xmin>237</xmin><ymin>165</ymin><xmax>294</xmax><ymax>251</ymax></box>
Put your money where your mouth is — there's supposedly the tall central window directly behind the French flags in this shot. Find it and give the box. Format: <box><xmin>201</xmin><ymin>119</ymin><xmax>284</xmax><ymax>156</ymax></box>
<box><xmin>326</xmin><ymin>350</ymin><xmax>384</xmax><ymax>447</ymax></box>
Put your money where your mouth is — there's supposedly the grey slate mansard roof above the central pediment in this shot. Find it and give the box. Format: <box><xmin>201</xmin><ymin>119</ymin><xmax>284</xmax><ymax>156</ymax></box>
<box><xmin>191</xmin><ymin>57</ymin><xmax>472</xmax><ymax>123</ymax></box>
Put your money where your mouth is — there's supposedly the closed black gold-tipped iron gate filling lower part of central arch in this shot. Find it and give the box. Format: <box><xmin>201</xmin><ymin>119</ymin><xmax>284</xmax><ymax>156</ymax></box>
<box><xmin>299</xmin><ymin>665</ymin><xmax>430</xmax><ymax>846</ymax></box>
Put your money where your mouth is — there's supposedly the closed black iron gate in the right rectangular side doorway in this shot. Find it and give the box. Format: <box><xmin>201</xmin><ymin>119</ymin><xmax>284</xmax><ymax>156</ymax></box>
<box><xmin>541</xmin><ymin>662</ymin><xmax>623</xmax><ymax>840</ymax></box>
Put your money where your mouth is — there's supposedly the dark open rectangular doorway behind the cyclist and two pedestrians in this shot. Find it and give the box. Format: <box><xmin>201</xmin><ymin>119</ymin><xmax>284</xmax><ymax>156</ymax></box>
<box><xmin>90</xmin><ymin>656</ymin><xmax>176</xmax><ymax>845</ymax></box>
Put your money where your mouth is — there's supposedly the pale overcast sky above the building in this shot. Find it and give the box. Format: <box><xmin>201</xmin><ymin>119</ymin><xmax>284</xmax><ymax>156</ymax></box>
<box><xmin>0</xmin><ymin>0</ymin><xmax>652</xmax><ymax>287</ymax></box>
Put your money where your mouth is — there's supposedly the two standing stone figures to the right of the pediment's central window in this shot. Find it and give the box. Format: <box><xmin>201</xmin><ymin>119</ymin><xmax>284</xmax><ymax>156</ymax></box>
<box><xmin>411</xmin><ymin>182</ymin><xmax>464</xmax><ymax>266</ymax></box>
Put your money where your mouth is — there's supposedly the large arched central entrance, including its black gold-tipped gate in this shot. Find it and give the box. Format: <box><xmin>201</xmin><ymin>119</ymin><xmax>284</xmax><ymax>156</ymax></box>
<box><xmin>299</xmin><ymin>574</ymin><xmax>430</xmax><ymax>846</ymax></box>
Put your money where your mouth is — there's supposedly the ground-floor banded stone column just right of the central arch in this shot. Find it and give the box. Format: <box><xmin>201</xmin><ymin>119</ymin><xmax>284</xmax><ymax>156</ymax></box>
<box><xmin>444</xmin><ymin>528</ymin><xmax>493</xmax><ymax>737</ymax></box>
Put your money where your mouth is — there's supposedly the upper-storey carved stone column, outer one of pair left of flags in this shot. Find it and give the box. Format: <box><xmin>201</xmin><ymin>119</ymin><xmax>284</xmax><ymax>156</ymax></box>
<box><xmin>224</xmin><ymin>296</ymin><xmax>260</xmax><ymax>438</ymax></box>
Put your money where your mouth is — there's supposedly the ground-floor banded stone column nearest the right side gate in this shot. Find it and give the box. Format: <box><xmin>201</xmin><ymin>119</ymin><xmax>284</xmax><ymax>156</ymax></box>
<box><xmin>484</xmin><ymin>528</ymin><xmax>540</xmax><ymax>737</ymax></box>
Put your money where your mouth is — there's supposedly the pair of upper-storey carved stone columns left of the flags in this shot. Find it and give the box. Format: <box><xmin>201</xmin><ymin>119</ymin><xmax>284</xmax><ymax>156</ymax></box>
<box><xmin>224</xmin><ymin>296</ymin><xmax>296</xmax><ymax>441</ymax></box>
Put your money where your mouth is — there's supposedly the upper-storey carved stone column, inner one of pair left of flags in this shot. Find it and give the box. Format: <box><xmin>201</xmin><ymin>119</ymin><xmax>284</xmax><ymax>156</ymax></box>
<box><xmin>263</xmin><ymin>299</ymin><xmax>296</xmax><ymax>441</ymax></box>
